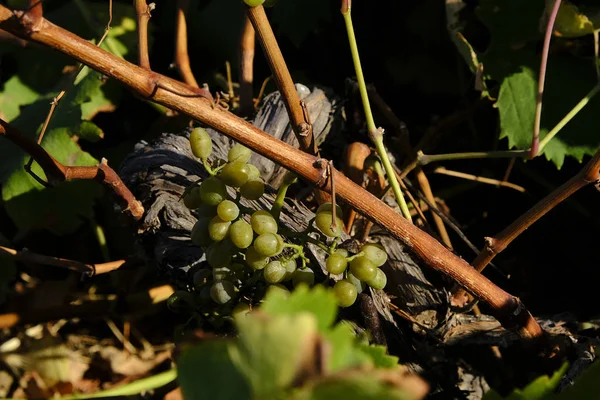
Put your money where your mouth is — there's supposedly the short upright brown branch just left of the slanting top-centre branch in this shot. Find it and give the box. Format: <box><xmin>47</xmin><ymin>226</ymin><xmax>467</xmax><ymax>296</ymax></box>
<box><xmin>238</xmin><ymin>15</ymin><xmax>256</xmax><ymax>116</ymax></box>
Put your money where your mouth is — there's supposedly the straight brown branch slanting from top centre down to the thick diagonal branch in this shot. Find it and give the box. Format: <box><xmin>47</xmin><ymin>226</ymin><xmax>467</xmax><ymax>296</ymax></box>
<box><xmin>246</xmin><ymin>6</ymin><xmax>319</xmax><ymax>155</ymax></box>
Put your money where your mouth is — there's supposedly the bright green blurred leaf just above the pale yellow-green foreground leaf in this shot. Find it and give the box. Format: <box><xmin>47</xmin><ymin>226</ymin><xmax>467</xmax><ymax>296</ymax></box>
<box><xmin>260</xmin><ymin>285</ymin><xmax>337</xmax><ymax>332</ymax></box>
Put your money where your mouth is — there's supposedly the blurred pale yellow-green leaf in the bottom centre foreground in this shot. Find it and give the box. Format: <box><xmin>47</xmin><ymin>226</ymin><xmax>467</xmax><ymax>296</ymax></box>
<box><xmin>229</xmin><ymin>312</ymin><xmax>317</xmax><ymax>398</ymax></box>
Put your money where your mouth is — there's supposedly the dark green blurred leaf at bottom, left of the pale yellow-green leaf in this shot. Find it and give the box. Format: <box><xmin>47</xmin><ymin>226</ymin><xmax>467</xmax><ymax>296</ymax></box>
<box><xmin>177</xmin><ymin>341</ymin><xmax>252</xmax><ymax>400</ymax></box>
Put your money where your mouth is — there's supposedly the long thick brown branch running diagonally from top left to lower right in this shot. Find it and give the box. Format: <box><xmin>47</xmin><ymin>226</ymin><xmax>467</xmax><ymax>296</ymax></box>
<box><xmin>0</xmin><ymin>6</ymin><xmax>544</xmax><ymax>344</ymax></box>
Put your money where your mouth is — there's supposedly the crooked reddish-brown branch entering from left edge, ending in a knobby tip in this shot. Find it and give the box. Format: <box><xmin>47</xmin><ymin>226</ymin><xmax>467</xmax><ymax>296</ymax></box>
<box><xmin>0</xmin><ymin>118</ymin><xmax>144</xmax><ymax>221</ymax></box>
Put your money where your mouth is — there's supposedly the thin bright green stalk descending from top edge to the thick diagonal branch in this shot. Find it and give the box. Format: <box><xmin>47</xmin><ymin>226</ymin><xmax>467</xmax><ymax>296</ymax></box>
<box><xmin>342</xmin><ymin>6</ymin><xmax>412</xmax><ymax>223</ymax></box>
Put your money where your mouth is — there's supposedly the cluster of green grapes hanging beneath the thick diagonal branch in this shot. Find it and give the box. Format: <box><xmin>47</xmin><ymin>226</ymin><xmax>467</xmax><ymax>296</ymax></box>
<box><xmin>183</xmin><ymin>128</ymin><xmax>387</xmax><ymax>314</ymax></box>
